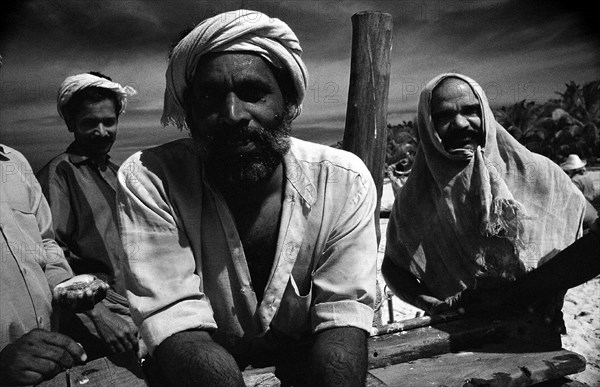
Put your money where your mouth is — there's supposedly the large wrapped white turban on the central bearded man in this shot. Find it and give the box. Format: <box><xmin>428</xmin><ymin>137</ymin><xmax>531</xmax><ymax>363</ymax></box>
<box><xmin>161</xmin><ymin>9</ymin><xmax>308</xmax><ymax>129</ymax></box>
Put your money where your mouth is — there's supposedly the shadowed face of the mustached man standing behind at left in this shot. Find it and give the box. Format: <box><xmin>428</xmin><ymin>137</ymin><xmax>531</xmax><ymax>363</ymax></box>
<box><xmin>73</xmin><ymin>99</ymin><xmax>118</xmax><ymax>161</ymax></box>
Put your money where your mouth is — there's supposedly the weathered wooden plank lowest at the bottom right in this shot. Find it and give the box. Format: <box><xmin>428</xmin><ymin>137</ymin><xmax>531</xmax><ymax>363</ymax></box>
<box><xmin>369</xmin><ymin>349</ymin><xmax>585</xmax><ymax>387</ymax></box>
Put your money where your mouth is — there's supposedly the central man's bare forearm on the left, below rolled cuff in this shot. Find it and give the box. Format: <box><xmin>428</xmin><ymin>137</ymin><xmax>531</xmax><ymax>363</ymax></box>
<box><xmin>154</xmin><ymin>331</ymin><xmax>245</xmax><ymax>387</ymax></box>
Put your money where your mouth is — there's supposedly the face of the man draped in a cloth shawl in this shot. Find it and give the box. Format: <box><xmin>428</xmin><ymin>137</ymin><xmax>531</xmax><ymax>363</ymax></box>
<box><xmin>431</xmin><ymin>78</ymin><xmax>483</xmax><ymax>153</ymax></box>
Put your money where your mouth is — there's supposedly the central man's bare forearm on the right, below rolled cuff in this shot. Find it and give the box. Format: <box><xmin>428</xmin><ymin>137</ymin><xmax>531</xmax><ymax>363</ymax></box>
<box><xmin>309</xmin><ymin>327</ymin><xmax>368</xmax><ymax>387</ymax></box>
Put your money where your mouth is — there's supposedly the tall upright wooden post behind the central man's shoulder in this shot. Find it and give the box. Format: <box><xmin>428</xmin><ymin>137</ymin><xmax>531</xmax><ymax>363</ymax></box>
<box><xmin>343</xmin><ymin>12</ymin><xmax>392</xmax><ymax>243</ymax></box>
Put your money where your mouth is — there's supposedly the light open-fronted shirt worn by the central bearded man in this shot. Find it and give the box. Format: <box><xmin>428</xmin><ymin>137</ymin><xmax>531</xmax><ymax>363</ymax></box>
<box><xmin>117</xmin><ymin>139</ymin><xmax>377</xmax><ymax>352</ymax></box>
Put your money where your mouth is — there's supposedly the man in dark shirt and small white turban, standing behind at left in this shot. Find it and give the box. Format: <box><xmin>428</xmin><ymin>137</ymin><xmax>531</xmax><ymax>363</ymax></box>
<box><xmin>37</xmin><ymin>72</ymin><xmax>145</xmax><ymax>386</ymax></box>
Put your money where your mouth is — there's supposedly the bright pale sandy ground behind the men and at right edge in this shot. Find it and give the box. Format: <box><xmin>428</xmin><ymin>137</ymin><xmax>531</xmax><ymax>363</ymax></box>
<box><xmin>377</xmin><ymin>179</ymin><xmax>600</xmax><ymax>387</ymax></box>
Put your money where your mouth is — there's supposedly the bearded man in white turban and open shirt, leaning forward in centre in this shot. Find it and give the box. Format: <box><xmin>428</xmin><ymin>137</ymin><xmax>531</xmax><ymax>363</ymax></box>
<box><xmin>117</xmin><ymin>10</ymin><xmax>377</xmax><ymax>386</ymax></box>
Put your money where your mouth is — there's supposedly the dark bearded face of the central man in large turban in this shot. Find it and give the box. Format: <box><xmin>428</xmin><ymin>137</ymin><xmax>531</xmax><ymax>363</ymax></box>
<box><xmin>187</xmin><ymin>53</ymin><xmax>289</xmax><ymax>188</ymax></box>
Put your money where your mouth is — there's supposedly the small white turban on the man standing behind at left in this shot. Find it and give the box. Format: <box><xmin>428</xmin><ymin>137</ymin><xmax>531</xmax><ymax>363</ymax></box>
<box><xmin>56</xmin><ymin>73</ymin><xmax>137</xmax><ymax>119</ymax></box>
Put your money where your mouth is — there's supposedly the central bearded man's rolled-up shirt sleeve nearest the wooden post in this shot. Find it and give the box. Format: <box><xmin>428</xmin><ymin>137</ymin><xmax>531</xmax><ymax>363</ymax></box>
<box><xmin>311</xmin><ymin>168</ymin><xmax>377</xmax><ymax>332</ymax></box>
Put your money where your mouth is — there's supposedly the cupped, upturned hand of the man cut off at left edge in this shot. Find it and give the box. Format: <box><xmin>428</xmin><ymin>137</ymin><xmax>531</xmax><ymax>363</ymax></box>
<box><xmin>52</xmin><ymin>274</ymin><xmax>109</xmax><ymax>312</ymax></box>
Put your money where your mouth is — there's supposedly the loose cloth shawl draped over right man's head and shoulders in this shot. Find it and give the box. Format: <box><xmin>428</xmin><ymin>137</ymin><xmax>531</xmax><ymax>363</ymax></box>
<box><xmin>385</xmin><ymin>74</ymin><xmax>585</xmax><ymax>299</ymax></box>
